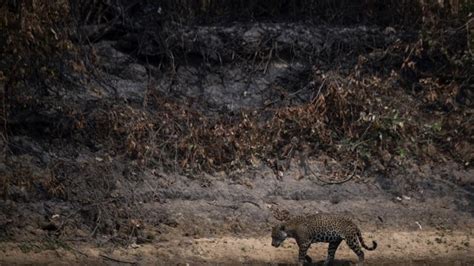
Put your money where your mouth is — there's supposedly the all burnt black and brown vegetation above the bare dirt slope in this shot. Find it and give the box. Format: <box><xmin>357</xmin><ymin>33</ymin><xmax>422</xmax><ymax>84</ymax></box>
<box><xmin>0</xmin><ymin>0</ymin><xmax>474</xmax><ymax>240</ymax></box>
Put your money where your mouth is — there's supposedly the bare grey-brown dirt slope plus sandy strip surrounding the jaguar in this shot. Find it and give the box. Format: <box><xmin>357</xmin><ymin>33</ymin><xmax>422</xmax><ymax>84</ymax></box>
<box><xmin>0</xmin><ymin>162</ymin><xmax>474</xmax><ymax>265</ymax></box>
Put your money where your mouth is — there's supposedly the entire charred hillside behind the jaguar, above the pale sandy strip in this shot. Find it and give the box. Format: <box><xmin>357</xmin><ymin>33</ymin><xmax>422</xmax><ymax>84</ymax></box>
<box><xmin>0</xmin><ymin>0</ymin><xmax>474</xmax><ymax>256</ymax></box>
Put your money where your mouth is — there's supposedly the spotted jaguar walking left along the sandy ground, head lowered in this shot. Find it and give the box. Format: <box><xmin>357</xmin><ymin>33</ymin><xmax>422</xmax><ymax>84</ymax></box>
<box><xmin>272</xmin><ymin>214</ymin><xmax>377</xmax><ymax>265</ymax></box>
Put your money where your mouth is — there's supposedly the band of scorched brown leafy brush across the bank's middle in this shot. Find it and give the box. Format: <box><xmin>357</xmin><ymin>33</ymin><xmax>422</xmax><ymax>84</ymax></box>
<box><xmin>92</xmin><ymin>50</ymin><xmax>472</xmax><ymax>174</ymax></box>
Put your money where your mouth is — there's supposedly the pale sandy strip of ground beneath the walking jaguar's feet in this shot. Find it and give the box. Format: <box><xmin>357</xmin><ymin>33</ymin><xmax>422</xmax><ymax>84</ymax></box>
<box><xmin>0</xmin><ymin>230</ymin><xmax>474</xmax><ymax>265</ymax></box>
